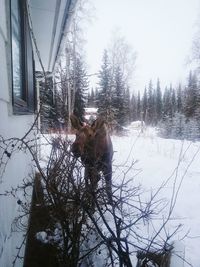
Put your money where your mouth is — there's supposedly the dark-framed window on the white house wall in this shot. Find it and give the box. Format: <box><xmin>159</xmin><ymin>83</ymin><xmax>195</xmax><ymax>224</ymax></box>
<box><xmin>11</xmin><ymin>0</ymin><xmax>35</xmax><ymax>114</ymax></box>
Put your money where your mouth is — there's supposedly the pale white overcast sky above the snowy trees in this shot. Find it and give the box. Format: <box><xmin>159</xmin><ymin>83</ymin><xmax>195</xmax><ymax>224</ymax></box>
<box><xmin>85</xmin><ymin>0</ymin><xmax>200</xmax><ymax>91</ymax></box>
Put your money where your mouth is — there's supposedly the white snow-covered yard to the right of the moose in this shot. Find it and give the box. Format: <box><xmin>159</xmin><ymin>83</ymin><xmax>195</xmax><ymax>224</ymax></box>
<box><xmin>39</xmin><ymin>128</ymin><xmax>200</xmax><ymax>267</ymax></box>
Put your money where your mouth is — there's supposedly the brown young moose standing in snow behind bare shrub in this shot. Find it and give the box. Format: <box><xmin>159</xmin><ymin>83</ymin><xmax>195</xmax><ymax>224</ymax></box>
<box><xmin>70</xmin><ymin>115</ymin><xmax>113</xmax><ymax>200</ymax></box>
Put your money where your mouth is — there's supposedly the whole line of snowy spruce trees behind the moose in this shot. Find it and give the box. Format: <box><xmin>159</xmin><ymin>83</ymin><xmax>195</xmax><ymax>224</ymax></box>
<box><xmin>40</xmin><ymin>47</ymin><xmax>200</xmax><ymax>142</ymax></box>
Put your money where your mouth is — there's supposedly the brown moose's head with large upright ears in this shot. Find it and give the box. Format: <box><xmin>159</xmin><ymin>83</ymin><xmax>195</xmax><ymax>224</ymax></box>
<box><xmin>70</xmin><ymin>115</ymin><xmax>106</xmax><ymax>163</ymax></box>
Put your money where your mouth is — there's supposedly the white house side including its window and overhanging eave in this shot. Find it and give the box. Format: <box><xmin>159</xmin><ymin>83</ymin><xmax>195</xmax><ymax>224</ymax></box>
<box><xmin>0</xmin><ymin>0</ymin><xmax>76</xmax><ymax>267</ymax></box>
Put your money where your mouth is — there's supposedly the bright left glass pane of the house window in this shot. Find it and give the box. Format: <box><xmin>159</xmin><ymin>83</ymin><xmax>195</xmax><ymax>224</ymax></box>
<box><xmin>11</xmin><ymin>0</ymin><xmax>24</xmax><ymax>99</ymax></box>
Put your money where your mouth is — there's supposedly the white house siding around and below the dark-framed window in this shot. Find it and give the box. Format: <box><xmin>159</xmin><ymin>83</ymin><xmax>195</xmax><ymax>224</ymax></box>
<box><xmin>0</xmin><ymin>0</ymin><xmax>34</xmax><ymax>267</ymax></box>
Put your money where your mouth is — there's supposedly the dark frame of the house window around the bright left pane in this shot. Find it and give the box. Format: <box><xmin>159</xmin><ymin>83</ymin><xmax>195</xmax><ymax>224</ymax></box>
<box><xmin>10</xmin><ymin>0</ymin><xmax>36</xmax><ymax>115</ymax></box>
